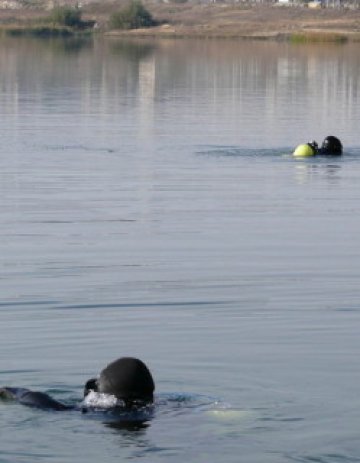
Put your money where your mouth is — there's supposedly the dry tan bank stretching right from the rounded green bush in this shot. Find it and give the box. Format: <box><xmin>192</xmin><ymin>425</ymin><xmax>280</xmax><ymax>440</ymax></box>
<box><xmin>108</xmin><ymin>3</ymin><xmax>360</xmax><ymax>41</ymax></box>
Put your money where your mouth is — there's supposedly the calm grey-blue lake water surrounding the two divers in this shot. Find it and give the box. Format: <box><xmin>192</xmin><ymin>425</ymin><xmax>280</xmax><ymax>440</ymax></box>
<box><xmin>0</xmin><ymin>39</ymin><xmax>360</xmax><ymax>463</ymax></box>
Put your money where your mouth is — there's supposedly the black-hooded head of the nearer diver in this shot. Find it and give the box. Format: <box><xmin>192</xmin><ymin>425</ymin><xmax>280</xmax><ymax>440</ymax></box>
<box><xmin>96</xmin><ymin>357</ymin><xmax>155</xmax><ymax>404</ymax></box>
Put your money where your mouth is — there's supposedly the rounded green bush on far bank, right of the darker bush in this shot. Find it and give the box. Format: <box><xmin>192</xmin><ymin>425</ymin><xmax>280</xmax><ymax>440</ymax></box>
<box><xmin>110</xmin><ymin>0</ymin><xmax>156</xmax><ymax>29</ymax></box>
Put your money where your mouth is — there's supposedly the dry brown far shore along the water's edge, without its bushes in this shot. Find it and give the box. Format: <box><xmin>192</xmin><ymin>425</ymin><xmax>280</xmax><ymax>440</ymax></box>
<box><xmin>0</xmin><ymin>2</ymin><xmax>360</xmax><ymax>43</ymax></box>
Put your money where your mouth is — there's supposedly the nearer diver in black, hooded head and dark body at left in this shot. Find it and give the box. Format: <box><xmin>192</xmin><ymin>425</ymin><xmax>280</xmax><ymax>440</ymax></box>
<box><xmin>0</xmin><ymin>357</ymin><xmax>155</xmax><ymax>411</ymax></box>
